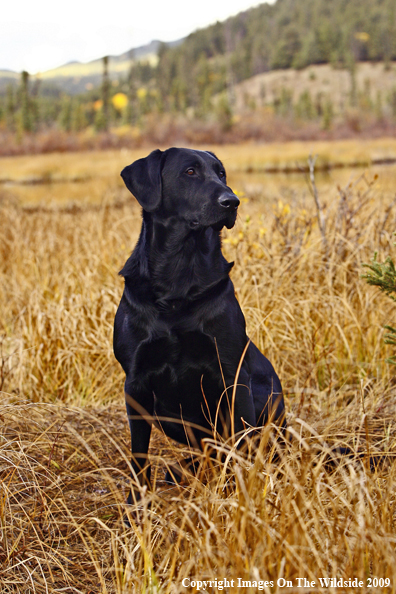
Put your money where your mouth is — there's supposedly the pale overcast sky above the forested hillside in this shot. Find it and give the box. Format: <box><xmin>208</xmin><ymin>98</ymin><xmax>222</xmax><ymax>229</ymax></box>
<box><xmin>0</xmin><ymin>0</ymin><xmax>270</xmax><ymax>74</ymax></box>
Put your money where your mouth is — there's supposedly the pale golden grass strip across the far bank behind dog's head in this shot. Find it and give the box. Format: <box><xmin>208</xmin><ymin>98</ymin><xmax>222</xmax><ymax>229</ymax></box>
<box><xmin>0</xmin><ymin>138</ymin><xmax>396</xmax><ymax>182</ymax></box>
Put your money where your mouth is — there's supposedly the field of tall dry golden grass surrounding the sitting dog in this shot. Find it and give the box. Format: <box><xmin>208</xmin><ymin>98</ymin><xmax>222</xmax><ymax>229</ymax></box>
<box><xmin>0</xmin><ymin>149</ymin><xmax>396</xmax><ymax>594</ymax></box>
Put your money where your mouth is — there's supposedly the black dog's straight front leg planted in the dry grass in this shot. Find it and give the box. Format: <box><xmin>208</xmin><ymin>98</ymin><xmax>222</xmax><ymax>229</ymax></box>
<box><xmin>125</xmin><ymin>382</ymin><xmax>154</xmax><ymax>504</ymax></box>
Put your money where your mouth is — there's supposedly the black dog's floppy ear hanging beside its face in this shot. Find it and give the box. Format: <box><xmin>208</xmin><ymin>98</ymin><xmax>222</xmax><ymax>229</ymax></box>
<box><xmin>121</xmin><ymin>149</ymin><xmax>163</xmax><ymax>212</ymax></box>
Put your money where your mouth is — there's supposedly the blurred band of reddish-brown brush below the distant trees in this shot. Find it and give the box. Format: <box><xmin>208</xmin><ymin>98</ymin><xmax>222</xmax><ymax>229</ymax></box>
<box><xmin>0</xmin><ymin>108</ymin><xmax>396</xmax><ymax>156</ymax></box>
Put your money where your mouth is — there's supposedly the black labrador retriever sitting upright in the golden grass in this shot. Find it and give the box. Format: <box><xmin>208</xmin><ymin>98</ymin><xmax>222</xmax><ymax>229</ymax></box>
<box><xmin>114</xmin><ymin>148</ymin><xmax>285</xmax><ymax>503</ymax></box>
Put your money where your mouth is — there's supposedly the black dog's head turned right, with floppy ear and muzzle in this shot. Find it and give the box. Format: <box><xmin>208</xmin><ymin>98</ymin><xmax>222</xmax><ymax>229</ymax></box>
<box><xmin>121</xmin><ymin>148</ymin><xmax>239</xmax><ymax>230</ymax></box>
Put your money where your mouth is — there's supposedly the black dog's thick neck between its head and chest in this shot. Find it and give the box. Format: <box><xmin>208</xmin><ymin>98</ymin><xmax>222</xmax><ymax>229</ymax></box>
<box><xmin>138</xmin><ymin>213</ymin><xmax>233</xmax><ymax>306</ymax></box>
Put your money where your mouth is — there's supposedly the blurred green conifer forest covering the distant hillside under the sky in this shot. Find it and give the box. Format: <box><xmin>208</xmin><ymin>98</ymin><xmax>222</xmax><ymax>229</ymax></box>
<box><xmin>0</xmin><ymin>0</ymin><xmax>396</xmax><ymax>132</ymax></box>
